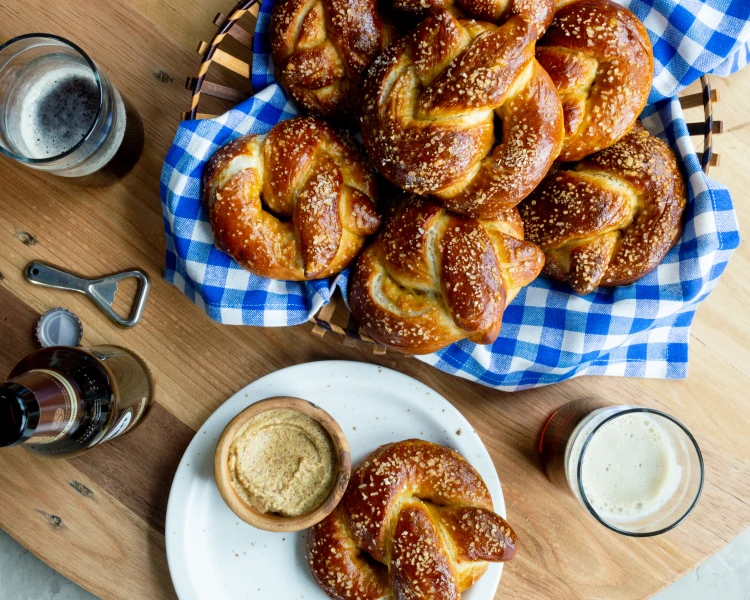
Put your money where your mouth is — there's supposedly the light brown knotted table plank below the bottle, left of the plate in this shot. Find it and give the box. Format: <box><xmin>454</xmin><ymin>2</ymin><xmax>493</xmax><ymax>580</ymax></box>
<box><xmin>0</xmin><ymin>448</ymin><xmax>175</xmax><ymax>600</ymax></box>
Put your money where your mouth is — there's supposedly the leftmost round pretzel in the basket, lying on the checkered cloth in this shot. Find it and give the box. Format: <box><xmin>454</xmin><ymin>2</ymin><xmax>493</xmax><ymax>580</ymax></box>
<box><xmin>203</xmin><ymin>117</ymin><xmax>380</xmax><ymax>281</ymax></box>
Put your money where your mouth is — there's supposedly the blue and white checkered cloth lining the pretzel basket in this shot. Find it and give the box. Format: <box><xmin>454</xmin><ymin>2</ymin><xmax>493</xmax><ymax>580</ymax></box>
<box><xmin>161</xmin><ymin>0</ymin><xmax>750</xmax><ymax>391</ymax></box>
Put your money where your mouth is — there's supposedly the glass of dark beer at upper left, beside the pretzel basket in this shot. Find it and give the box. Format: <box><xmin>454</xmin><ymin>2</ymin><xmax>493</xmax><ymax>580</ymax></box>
<box><xmin>0</xmin><ymin>33</ymin><xmax>144</xmax><ymax>185</ymax></box>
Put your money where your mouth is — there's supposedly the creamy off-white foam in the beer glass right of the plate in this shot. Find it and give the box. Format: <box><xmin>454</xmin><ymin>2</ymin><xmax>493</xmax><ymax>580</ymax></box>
<box><xmin>581</xmin><ymin>413</ymin><xmax>682</xmax><ymax>522</ymax></box>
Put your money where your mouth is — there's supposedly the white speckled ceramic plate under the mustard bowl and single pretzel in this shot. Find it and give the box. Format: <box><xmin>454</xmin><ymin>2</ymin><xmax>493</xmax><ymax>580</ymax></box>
<box><xmin>166</xmin><ymin>361</ymin><xmax>505</xmax><ymax>600</ymax></box>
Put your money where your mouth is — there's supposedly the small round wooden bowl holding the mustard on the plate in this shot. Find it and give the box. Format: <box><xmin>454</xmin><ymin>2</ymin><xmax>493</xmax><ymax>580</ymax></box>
<box><xmin>214</xmin><ymin>396</ymin><xmax>352</xmax><ymax>532</ymax></box>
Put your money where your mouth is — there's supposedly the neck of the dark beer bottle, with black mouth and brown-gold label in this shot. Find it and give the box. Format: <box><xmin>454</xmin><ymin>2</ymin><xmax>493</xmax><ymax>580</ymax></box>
<box><xmin>0</xmin><ymin>369</ymin><xmax>81</xmax><ymax>447</ymax></box>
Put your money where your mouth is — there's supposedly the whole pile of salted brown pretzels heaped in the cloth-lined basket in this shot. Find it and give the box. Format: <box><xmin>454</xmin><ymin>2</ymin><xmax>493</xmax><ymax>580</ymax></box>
<box><xmin>204</xmin><ymin>0</ymin><xmax>686</xmax><ymax>353</ymax></box>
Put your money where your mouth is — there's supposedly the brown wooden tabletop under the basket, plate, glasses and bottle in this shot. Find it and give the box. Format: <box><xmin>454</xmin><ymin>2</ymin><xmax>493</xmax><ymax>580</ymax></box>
<box><xmin>0</xmin><ymin>0</ymin><xmax>750</xmax><ymax>600</ymax></box>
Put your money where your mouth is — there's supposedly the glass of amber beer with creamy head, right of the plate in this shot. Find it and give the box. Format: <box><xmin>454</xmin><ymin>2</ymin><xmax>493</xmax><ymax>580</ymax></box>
<box><xmin>539</xmin><ymin>399</ymin><xmax>703</xmax><ymax>537</ymax></box>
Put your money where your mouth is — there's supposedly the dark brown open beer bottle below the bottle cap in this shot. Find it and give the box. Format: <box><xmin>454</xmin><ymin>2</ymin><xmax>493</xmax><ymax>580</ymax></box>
<box><xmin>0</xmin><ymin>346</ymin><xmax>153</xmax><ymax>458</ymax></box>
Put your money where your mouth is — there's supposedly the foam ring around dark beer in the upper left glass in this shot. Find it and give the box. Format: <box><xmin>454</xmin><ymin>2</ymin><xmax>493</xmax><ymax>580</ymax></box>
<box><xmin>18</xmin><ymin>63</ymin><xmax>99</xmax><ymax>158</ymax></box>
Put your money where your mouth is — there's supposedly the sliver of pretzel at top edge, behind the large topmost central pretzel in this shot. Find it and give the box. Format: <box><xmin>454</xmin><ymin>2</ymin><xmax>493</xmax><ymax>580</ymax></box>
<box><xmin>391</xmin><ymin>0</ymin><xmax>555</xmax><ymax>37</ymax></box>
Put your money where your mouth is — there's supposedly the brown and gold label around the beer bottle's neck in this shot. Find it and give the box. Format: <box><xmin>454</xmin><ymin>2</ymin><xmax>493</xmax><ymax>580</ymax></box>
<box><xmin>21</xmin><ymin>369</ymin><xmax>81</xmax><ymax>444</ymax></box>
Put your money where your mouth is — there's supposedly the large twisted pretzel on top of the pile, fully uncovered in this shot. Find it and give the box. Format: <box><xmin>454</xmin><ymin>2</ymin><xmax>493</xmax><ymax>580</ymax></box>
<box><xmin>361</xmin><ymin>10</ymin><xmax>563</xmax><ymax>218</ymax></box>
